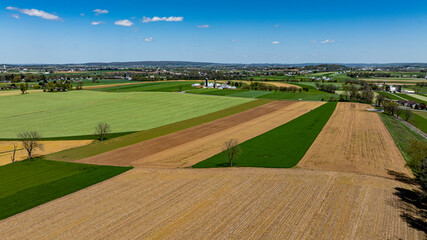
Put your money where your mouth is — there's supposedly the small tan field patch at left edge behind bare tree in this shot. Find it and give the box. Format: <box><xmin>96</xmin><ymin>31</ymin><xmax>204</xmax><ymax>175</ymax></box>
<box><xmin>0</xmin><ymin>140</ymin><xmax>92</xmax><ymax>166</ymax></box>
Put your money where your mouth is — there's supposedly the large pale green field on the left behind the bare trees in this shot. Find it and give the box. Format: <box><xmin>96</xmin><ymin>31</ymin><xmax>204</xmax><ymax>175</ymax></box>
<box><xmin>0</xmin><ymin>91</ymin><xmax>252</xmax><ymax>139</ymax></box>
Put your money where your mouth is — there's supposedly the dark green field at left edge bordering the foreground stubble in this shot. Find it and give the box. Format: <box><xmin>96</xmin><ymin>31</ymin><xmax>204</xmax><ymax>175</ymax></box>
<box><xmin>0</xmin><ymin>159</ymin><xmax>131</xmax><ymax>219</ymax></box>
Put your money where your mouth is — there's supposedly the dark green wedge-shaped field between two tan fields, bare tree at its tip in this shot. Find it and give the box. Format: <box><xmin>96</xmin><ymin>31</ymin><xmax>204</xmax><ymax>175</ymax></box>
<box><xmin>193</xmin><ymin>102</ymin><xmax>336</xmax><ymax>168</ymax></box>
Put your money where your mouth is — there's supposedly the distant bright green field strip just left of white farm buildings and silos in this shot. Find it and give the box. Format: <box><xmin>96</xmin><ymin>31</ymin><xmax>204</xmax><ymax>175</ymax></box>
<box><xmin>96</xmin><ymin>81</ymin><xmax>199</xmax><ymax>92</ymax></box>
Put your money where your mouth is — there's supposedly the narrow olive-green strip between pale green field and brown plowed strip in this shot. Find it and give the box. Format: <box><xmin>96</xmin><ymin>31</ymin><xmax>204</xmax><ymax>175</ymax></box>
<box><xmin>45</xmin><ymin>100</ymin><xmax>271</xmax><ymax>161</ymax></box>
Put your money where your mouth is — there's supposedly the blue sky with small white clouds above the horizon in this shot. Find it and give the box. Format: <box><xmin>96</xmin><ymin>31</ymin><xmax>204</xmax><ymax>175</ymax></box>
<box><xmin>0</xmin><ymin>0</ymin><xmax>427</xmax><ymax>64</ymax></box>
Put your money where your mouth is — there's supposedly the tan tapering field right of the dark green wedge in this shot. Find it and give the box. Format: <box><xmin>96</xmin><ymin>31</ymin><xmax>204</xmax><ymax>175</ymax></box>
<box><xmin>297</xmin><ymin>103</ymin><xmax>411</xmax><ymax>176</ymax></box>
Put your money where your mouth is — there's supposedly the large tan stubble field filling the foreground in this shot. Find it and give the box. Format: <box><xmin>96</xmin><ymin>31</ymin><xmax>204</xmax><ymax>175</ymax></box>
<box><xmin>0</xmin><ymin>168</ymin><xmax>425</xmax><ymax>240</ymax></box>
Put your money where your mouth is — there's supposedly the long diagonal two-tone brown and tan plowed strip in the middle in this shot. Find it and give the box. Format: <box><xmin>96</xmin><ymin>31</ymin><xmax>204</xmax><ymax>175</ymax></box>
<box><xmin>78</xmin><ymin>101</ymin><xmax>324</xmax><ymax>168</ymax></box>
